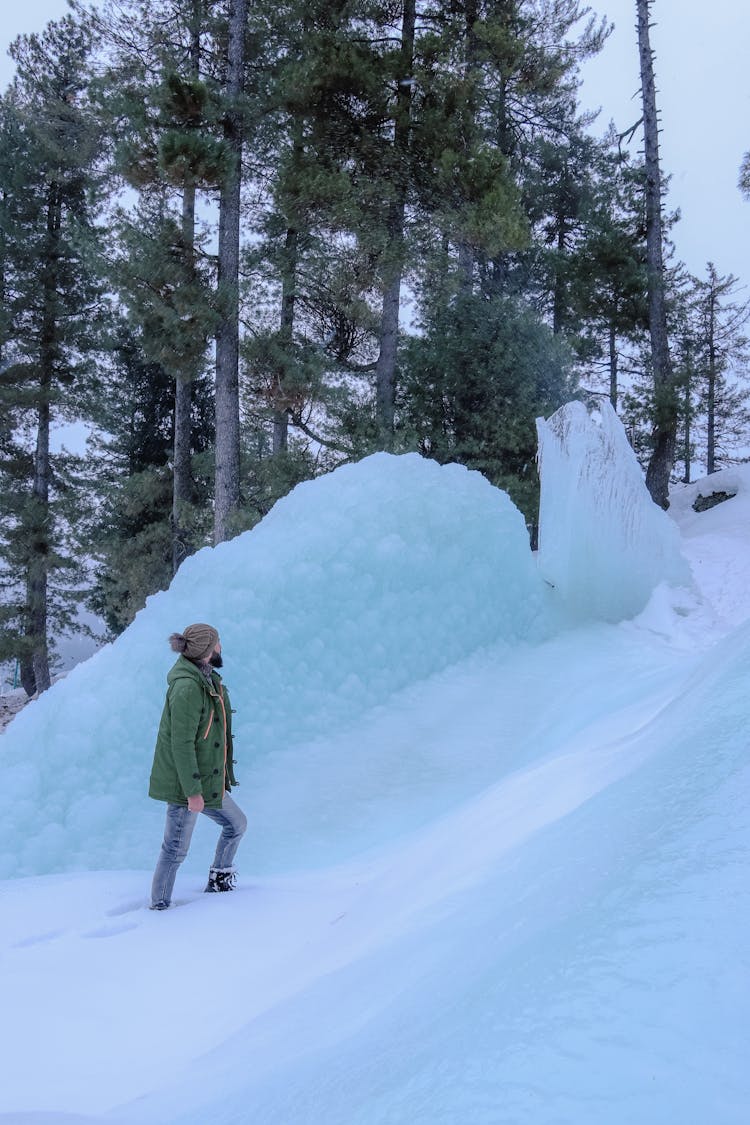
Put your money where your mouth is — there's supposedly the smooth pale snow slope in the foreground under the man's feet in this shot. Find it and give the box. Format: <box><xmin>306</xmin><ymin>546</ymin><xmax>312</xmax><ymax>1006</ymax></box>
<box><xmin>0</xmin><ymin>598</ymin><xmax>750</xmax><ymax>1125</ymax></box>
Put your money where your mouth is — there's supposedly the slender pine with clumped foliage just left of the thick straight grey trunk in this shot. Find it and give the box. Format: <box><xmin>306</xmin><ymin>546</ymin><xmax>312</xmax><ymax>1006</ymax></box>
<box><xmin>92</xmin><ymin>0</ymin><xmax>227</xmax><ymax>573</ymax></box>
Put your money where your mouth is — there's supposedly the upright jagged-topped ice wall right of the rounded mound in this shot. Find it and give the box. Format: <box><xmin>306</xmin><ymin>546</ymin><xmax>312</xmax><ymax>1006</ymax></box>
<box><xmin>536</xmin><ymin>402</ymin><xmax>690</xmax><ymax>621</ymax></box>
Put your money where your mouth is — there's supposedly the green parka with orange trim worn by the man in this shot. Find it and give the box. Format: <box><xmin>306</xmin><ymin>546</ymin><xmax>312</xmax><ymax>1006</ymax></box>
<box><xmin>148</xmin><ymin>656</ymin><xmax>237</xmax><ymax>809</ymax></box>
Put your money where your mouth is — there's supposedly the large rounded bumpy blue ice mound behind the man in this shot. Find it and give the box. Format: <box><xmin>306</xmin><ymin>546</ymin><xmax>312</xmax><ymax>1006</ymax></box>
<box><xmin>0</xmin><ymin>453</ymin><xmax>545</xmax><ymax>878</ymax></box>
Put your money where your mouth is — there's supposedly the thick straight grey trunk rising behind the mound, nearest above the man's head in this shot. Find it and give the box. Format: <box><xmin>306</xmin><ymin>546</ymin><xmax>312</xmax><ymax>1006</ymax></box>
<box><xmin>214</xmin><ymin>0</ymin><xmax>246</xmax><ymax>543</ymax></box>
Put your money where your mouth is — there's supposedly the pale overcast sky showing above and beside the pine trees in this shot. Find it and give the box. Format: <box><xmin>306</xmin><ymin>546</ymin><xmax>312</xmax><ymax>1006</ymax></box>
<box><xmin>0</xmin><ymin>0</ymin><xmax>750</xmax><ymax>285</ymax></box>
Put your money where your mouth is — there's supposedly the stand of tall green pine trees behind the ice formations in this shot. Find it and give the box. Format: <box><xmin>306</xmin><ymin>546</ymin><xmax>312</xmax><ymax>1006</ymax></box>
<box><xmin>0</xmin><ymin>0</ymin><xmax>748</xmax><ymax>693</ymax></box>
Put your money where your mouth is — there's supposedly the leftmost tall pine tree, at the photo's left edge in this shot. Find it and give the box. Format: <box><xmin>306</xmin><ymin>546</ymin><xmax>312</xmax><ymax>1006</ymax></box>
<box><xmin>0</xmin><ymin>16</ymin><xmax>101</xmax><ymax>693</ymax></box>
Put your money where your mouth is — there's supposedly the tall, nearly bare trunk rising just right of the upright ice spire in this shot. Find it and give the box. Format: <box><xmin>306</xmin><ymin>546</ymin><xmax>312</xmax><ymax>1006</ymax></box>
<box><xmin>636</xmin><ymin>0</ymin><xmax>677</xmax><ymax>509</ymax></box>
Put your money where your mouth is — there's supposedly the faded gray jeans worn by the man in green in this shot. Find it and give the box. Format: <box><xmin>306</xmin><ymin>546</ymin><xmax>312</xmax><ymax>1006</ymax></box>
<box><xmin>151</xmin><ymin>793</ymin><xmax>247</xmax><ymax>907</ymax></box>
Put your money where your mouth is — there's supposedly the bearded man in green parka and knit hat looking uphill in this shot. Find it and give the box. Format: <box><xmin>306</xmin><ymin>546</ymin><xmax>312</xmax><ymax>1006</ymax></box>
<box><xmin>148</xmin><ymin>624</ymin><xmax>247</xmax><ymax>910</ymax></box>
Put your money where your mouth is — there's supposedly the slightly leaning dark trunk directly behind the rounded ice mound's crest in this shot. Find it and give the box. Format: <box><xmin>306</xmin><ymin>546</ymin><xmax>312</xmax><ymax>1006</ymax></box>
<box><xmin>376</xmin><ymin>0</ymin><xmax>416</xmax><ymax>449</ymax></box>
